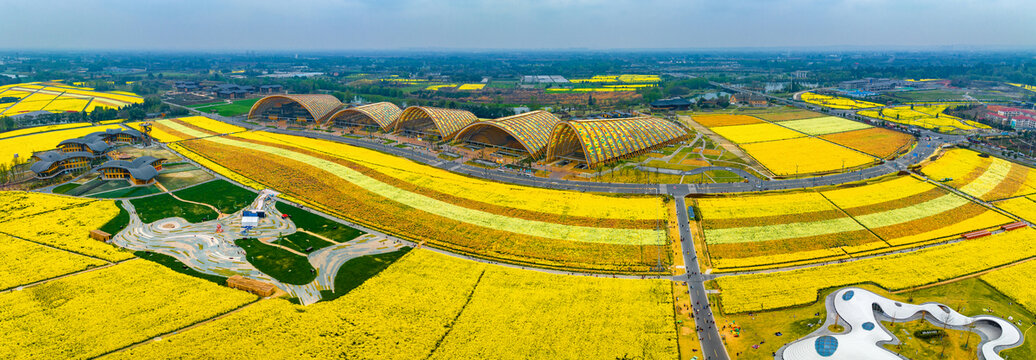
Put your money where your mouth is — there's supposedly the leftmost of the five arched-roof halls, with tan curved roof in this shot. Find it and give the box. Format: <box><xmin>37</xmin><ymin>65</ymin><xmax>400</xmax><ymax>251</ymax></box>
<box><xmin>249</xmin><ymin>94</ymin><xmax>342</xmax><ymax>122</ymax></box>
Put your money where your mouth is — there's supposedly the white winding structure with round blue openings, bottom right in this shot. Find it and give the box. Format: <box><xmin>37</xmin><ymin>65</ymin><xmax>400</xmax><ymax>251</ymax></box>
<box><xmin>776</xmin><ymin>287</ymin><xmax>1024</xmax><ymax>360</ymax></box>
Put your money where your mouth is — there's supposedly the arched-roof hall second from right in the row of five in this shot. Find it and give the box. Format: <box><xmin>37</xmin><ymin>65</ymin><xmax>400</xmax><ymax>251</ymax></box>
<box><xmin>455</xmin><ymin>110</ymin><xmax>562</xmax><ymax>159</ymax></box>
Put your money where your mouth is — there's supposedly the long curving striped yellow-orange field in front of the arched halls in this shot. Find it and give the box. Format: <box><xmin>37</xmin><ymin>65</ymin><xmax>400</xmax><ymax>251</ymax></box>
<box><xmin>158</xmin><ymin>122</ymin><xmax>667</xmax><ymax>272</ymax></box>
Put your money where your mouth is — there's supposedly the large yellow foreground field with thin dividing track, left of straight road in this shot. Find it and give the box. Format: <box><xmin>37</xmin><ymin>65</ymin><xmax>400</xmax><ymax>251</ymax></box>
<box><xmin>112</xmin><ymin>249</ymin><xmax>677</xmax><ymax>359</ymax></box>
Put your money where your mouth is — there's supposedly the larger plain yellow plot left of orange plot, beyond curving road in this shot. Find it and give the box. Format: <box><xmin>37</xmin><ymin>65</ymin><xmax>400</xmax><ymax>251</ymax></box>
<box><xmin>740</xmin><ymin>138</ymin><xmax>875</xmax><ymax>175</ymax></box>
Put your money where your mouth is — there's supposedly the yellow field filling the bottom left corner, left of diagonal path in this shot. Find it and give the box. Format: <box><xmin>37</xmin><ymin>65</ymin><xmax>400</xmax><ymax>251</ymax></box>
<box><xmin>0</xmin><ymin>259</ymin><xmax>256</xmax><ymax>359</ymax></box>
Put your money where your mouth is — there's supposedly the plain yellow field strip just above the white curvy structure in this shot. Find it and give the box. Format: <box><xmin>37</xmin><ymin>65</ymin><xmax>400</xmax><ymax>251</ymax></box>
<box><xmin>716</xmin><ymin>228</ymin><xmax>1036</xmax><ymax>313</ymax></box>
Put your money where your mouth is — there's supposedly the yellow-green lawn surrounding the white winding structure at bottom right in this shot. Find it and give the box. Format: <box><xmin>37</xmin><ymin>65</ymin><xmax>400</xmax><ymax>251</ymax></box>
<box><xmin>710</xmin><ymin>278</ymin><xmax>1036</xmax><ymax>360</ymax></box>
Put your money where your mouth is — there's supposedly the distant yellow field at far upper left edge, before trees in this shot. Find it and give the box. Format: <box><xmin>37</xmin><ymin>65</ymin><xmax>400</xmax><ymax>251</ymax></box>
<box><xmin>0</xmin><ymin>82</ymin><xmax>144</xmax><ymax>116</ymax></box>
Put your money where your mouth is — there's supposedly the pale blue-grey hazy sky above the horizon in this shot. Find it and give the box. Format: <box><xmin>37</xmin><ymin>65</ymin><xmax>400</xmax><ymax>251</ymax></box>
<box><xmin>0</xmin><ymin>0</ymin><xmax>1036</xmax><ymax>50</ymax></box>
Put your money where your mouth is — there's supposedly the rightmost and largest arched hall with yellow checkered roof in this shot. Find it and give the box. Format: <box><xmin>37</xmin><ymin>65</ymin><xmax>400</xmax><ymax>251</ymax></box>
<box><xmin>546</xmin><ymin>116</ymin><xmax>687</xmax><ymax>167</ymax></box>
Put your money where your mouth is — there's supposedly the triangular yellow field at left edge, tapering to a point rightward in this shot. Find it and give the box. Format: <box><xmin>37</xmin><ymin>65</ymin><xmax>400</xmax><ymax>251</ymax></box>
<box><xmin>0</xmin><ymin>233</ymin><xmax>106</xmax><ymax>290</ymax></box>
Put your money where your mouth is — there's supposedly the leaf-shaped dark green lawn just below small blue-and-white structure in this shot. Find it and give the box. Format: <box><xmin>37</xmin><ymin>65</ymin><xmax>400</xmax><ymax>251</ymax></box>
<box><xmin>234</xmin><ymin>239</ymin><xmax>317</xmax><ymax>285</ymax></box>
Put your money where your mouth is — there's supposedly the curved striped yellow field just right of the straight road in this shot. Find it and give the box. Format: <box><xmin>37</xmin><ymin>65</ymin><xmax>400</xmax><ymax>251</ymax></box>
<box><xmin>695</xmin><ymin>176</ymin><xmax>1012</xmax><ymax>271</ymax></box>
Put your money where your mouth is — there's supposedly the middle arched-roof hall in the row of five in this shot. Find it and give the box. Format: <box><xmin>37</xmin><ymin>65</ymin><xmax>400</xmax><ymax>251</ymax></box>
<box><xmin>393</xmin><ymin>106</ymin><xmax>479</xmax><ymax>140</ymax></box>
